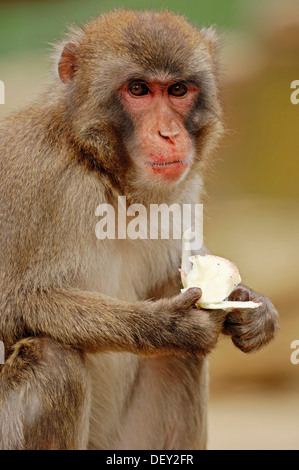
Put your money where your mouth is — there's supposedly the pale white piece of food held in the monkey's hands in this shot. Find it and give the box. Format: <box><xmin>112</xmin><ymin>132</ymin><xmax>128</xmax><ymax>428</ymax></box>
<box><xmin>180</xmin><ymin>250</ymin><xmax>261</xmax><ymax>309</ymax></box>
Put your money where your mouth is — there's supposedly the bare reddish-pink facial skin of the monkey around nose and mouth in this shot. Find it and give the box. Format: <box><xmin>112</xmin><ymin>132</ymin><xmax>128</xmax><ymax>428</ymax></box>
<box><xmin>121</xmin><ymin>80</ymin><xmax>198</xmax><ymax>182</ymax></box>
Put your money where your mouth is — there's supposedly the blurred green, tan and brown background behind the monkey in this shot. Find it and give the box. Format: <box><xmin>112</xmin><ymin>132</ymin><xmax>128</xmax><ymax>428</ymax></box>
<box><xmin>0</xmin><ymin>0</ymin><xmax>299</xmax><ymax>449</ymax></box>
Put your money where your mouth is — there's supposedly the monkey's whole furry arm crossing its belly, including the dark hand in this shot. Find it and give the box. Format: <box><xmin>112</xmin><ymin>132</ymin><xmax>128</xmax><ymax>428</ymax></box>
<box><xmin>0</xmin><ymin>288</ymin><xmax>223</xmax><ymax>356</ymax></box>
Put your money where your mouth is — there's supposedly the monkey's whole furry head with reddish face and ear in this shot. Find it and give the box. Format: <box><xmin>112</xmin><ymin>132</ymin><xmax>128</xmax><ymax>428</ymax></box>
<box><xmin>58</xmin><ymin>10</ymin><xmax>222</xmax><ymax>198</ymax></box>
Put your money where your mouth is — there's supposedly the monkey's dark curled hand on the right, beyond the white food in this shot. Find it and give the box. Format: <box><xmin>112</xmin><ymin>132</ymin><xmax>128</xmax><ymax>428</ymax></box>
<box><xmin>223</xmin><ymin>285</ymin><xmax>278</xmax><ymax>353</ymax></box>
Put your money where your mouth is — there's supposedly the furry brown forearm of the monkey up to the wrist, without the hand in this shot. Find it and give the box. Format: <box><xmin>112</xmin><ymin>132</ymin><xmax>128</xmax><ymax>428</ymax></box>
<box><xmin>0</xmin><ymin>288</ymin><xmax>159</xmax><ymax>352</ymax></box>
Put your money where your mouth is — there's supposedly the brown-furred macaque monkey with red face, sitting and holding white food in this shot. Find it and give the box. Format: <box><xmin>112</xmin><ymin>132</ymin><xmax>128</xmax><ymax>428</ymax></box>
<box><xmin>0</xmin><ymin>10</ymin><xmax>277</xmax><ymax>449</ymax></box>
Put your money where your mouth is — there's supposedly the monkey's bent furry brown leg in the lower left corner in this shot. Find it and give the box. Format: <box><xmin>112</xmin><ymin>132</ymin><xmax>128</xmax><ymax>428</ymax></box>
<box><xmin>0</xmin><ymin>337</ymin><xmax>90</xmax><ymax>450</ymax></box>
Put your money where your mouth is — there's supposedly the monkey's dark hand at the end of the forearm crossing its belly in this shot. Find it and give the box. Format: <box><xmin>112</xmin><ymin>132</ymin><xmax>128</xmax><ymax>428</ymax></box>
<box><xmin>150</xmin><ymin>287</ymin><xmax>226</xmax><ymax>355</ymax></box>
